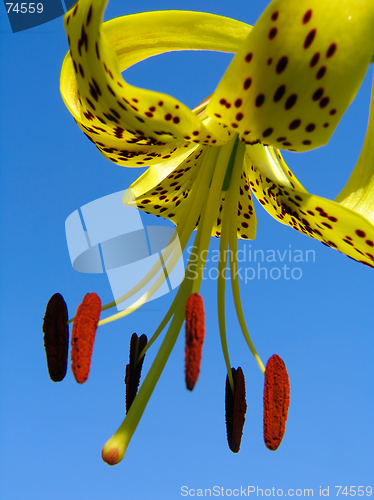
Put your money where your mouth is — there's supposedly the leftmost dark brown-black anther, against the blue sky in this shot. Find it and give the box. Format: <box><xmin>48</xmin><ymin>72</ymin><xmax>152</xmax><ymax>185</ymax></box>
<box><xmin>43</xmin><ymin>293</ymin><xmax>69</xmax><ymax>382</ymax></box>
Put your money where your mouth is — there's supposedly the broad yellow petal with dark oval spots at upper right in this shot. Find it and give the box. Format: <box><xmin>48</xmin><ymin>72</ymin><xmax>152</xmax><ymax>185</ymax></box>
<box><xmin>206</xmin><ymin>0</ymin><xmax>374</xmax><ymax>151</ymax></box>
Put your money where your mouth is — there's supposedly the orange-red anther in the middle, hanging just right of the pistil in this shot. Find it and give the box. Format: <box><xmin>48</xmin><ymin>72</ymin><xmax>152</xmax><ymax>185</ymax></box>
<box><xmin>185</xmin><ymin>293</ymin><xmax>205</xmax><ymax>391</ymax></box>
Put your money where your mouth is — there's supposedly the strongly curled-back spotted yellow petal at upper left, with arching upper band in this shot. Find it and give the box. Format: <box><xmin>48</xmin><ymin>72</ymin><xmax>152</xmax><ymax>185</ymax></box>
<box><xmin>60</xmin><ymin>0</ymin><xmax>250</xmax><ymax>166</ymax></box>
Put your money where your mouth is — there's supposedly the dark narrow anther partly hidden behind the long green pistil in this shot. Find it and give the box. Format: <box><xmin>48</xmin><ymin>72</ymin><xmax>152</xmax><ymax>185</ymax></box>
<box><xmin>125</xmin><ymin>333</ymin><xmax>147</xmax><ymax>413</ymax></box>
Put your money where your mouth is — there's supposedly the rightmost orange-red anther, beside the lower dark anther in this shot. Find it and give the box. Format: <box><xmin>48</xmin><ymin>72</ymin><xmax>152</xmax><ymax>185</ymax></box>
<box><xmin>264</xmin><ymin>354</ymin><xmax>290</xmax><ymax>450</ymax></box>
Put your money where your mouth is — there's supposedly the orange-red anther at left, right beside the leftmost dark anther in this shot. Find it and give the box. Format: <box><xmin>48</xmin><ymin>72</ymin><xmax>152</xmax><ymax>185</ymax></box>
<box><xmin>71</xmin><ymin>293</ymin><xmax>101</xmax><ymax>384</ymax></box>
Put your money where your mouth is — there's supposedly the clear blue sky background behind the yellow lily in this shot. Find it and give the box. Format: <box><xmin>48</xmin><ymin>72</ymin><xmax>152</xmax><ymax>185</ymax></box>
<box><xmin>0</xmin><ymin>0</ymin><xmax>374</xmax><ymax>500</ymax></box>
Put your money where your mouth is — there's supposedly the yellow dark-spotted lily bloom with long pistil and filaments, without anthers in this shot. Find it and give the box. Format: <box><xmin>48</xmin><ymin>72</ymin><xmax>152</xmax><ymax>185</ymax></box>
<box><xmin>60</xmin><ymin>0</ymin><xmax>374</xmax><ymax>464</ymax></box>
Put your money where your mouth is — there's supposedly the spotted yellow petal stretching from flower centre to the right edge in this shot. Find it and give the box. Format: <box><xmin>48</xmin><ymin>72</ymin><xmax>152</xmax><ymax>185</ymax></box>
<box><xmin>245</xmin><ymin>144</ymin><xmax>374</xmax><ymax>267</ymax></box>
